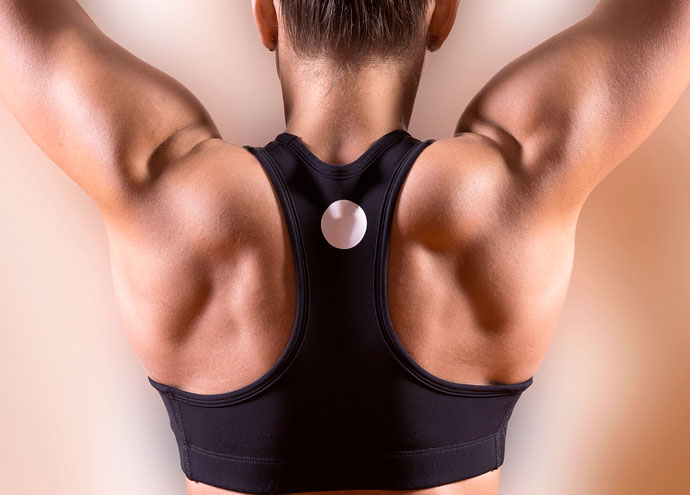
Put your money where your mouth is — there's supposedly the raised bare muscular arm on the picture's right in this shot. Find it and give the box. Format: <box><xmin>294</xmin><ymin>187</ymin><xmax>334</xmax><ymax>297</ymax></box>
<box><xmin>455</xmin><ymin>0</ymin><xmax>690</xmax><ymax>215</ymax></box>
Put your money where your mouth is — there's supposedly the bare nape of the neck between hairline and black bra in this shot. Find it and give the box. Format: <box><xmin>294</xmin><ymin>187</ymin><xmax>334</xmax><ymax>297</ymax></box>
<box><xmin>278</xmin><ymin>50</ymin><xmax>425</xmax><ymax>163</ymax></box>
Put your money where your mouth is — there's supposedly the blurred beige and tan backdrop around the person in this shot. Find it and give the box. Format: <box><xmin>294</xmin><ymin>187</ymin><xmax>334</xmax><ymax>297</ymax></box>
<box><xmin>0</xmin><ymin>0</ymin><xmax>690</xmax><ymax>495</ymax></box>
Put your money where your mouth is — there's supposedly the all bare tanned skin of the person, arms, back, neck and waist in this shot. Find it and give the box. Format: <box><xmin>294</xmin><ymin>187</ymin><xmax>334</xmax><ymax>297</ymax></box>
<box><xmin>0</xmin><ymin>0</ymin><xmax>690</xmax><ymax>495</ymax></box>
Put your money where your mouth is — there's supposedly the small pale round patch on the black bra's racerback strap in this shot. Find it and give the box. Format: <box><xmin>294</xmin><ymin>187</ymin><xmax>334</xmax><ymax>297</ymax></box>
<box><xmin>321</xmin><ymin>199</ymin><xmax>367</xmax><ymax>249</ymax></box>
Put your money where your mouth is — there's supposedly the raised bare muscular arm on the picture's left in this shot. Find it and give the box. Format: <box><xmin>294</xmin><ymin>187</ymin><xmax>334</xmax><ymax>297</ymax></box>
<box><xmin>0</xmin><ymin>0</ymin><xmax>220</xmax><ymax>215</ymax></box>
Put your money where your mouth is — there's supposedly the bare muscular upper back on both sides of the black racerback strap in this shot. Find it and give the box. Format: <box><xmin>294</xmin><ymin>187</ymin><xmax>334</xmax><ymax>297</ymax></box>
<box><xmin>102</xmin><ymin>133</ymin><xmax>576</xmax><ymax>393</ymax></box>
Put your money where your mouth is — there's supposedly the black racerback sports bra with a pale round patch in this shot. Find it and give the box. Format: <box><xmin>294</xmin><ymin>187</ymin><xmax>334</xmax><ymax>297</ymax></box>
<box><xmin>149</xmin><ymin>129</ymin><xmax>532</xmax><ymax>494</ymax></box>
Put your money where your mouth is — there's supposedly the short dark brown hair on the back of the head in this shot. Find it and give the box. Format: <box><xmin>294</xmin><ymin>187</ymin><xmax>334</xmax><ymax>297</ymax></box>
<box><xmin>280</xmin><ymin>0</ymin><xmax>430</xmax><ymax>67</ymax></box>
